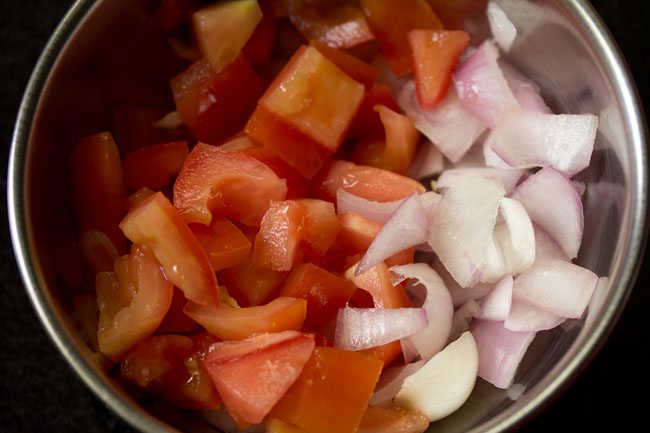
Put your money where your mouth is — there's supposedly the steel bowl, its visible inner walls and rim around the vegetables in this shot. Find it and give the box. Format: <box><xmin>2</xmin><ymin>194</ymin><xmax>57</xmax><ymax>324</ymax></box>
<box><xmin>8</xmin><ymin>0</ymin><xmax>648</xmax><ymax>433</ymax></box>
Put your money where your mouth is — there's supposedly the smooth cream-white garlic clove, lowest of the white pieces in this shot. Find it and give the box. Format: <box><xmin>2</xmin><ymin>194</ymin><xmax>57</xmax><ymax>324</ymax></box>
<box><xmin>395</xmin><ymin>332</ymin><xmax>479</xmax><ymax>421</ymax></box>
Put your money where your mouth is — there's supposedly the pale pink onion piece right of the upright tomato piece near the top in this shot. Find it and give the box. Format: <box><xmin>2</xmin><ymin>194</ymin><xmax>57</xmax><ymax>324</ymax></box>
<box><xmin>454</xmin><ymin>40</ymin><xmax>519</xmax><ymax>127</ymax></box>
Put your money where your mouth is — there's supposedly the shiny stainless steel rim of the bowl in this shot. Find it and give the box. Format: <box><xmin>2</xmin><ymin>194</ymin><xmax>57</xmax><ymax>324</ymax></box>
<box><xmin>7</xmin><ymin>0</ymin><xmax>648</xmax><ymax>433</ymax></box>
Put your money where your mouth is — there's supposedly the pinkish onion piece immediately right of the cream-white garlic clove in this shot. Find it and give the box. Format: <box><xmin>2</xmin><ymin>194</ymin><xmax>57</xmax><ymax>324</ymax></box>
<box><xmin>471</xmin><ymin>320</ymin><xmax>535</xmax><ymax>389</ymax></box>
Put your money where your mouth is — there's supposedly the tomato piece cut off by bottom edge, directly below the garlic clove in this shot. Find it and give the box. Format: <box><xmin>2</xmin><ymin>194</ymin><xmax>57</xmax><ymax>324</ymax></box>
<box><xmin>357</xmin><ymin>401</ymin><xmax>429</xmax><ymax>433</ymax></box>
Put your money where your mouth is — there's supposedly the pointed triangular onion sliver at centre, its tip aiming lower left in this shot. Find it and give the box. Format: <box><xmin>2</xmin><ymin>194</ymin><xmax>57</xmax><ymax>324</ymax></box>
<box><xmin>354</xmin><ymin>192</ymin><xmax>432</xmax><ymax>276</ymax></box>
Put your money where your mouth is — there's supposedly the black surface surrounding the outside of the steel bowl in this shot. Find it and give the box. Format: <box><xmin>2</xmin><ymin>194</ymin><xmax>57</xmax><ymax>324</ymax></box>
<box><xmin>0</xmin><ymin>0</ymin><xmax>650</xmax><ymax>433</ymax></box>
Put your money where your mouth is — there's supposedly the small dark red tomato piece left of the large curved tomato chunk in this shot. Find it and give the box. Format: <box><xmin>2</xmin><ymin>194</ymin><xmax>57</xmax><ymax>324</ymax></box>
<box><xmin>122</xmin><ymin>141</ymin><xmax>189</xmax><ymax>191</ymax></box>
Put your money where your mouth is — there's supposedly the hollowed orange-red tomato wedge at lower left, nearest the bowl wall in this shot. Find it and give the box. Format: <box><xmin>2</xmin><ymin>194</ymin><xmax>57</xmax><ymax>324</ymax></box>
<box><xmin>95</xmin><ymin>246</ymin><xmax>173</xmax><ymax>359</ymax></box>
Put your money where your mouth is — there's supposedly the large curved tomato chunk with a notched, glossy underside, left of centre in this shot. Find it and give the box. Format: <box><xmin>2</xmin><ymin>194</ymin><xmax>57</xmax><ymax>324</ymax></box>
<box><xmin>174</xmin><ymin>143</ymin><xmax>287</xmax><ymax>226</ymax></box>
